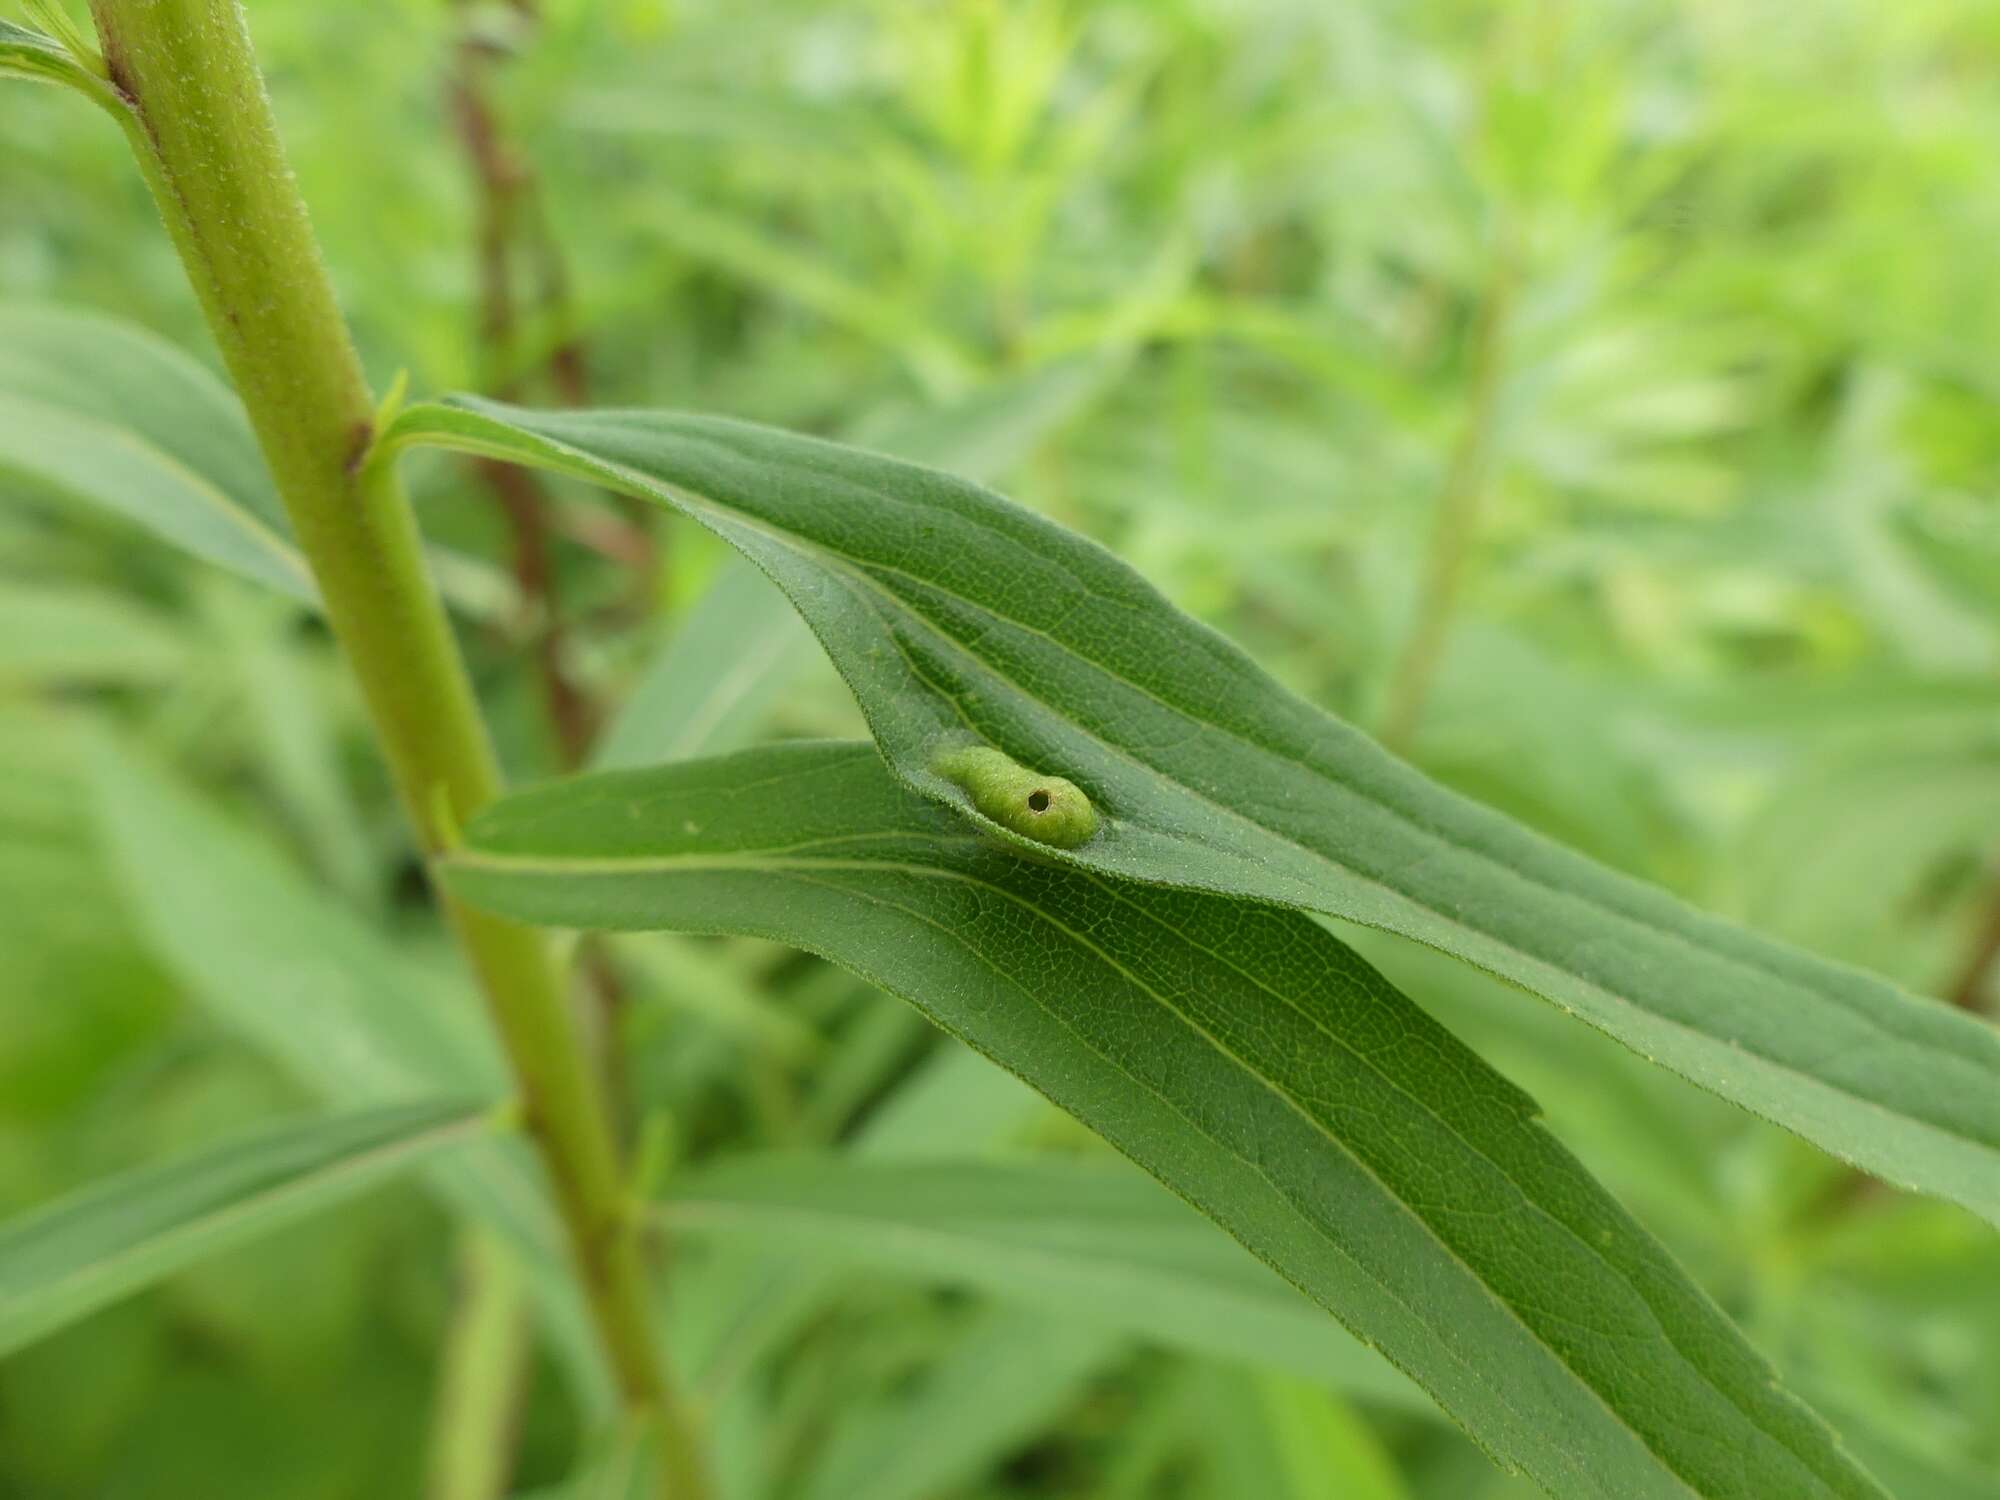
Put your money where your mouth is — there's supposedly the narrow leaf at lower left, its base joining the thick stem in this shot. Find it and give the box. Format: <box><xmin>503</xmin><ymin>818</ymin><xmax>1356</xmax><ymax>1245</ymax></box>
<box><xmin>0</xmin><ymin>1102</ymin><xmax>492</xmax><ymax>1354</ymax></box>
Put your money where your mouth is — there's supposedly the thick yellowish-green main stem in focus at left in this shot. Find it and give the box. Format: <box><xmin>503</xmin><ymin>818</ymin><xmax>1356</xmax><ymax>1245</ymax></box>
<box><xmin>92</xmin><ymin>0</ymin><xmax>708</xmax><ymax>1496</ymax></box>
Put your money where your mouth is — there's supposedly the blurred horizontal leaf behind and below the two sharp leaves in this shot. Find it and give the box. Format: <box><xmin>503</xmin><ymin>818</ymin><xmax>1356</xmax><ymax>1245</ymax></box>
<box><xmin>660</xmin><ymin>1154</ymin><xmax>1436</xmax><ymax>1416</ymax></box>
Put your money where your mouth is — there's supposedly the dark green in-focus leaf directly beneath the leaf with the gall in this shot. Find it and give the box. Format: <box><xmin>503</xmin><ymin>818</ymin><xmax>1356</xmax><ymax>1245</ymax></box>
<box><xmin>446</xmin><ymin>744</ymin><xmax>1880</xmax><ymax>1500</ymax></box>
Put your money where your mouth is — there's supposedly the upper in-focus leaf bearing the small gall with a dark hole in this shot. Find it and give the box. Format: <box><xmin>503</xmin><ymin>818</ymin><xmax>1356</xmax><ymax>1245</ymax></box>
<box><xmin>382</xmin><ymin>398</ymin><xmax>2000</xmax><ymax>1222</ymax></box>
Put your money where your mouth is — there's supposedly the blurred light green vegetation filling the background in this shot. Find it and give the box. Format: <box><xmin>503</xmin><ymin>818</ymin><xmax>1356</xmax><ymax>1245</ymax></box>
<box><xmin>0</xmin><ymin>0</ymin><xmax>2000</xmax><ymax>1500</ymax></box>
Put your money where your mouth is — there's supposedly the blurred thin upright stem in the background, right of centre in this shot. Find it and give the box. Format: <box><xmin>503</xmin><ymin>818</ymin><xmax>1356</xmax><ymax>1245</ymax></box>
<box><xmin>1382</xmin><ymin>251</ymin><xmax>1518</xmax><ymax>752</ymax></box>
